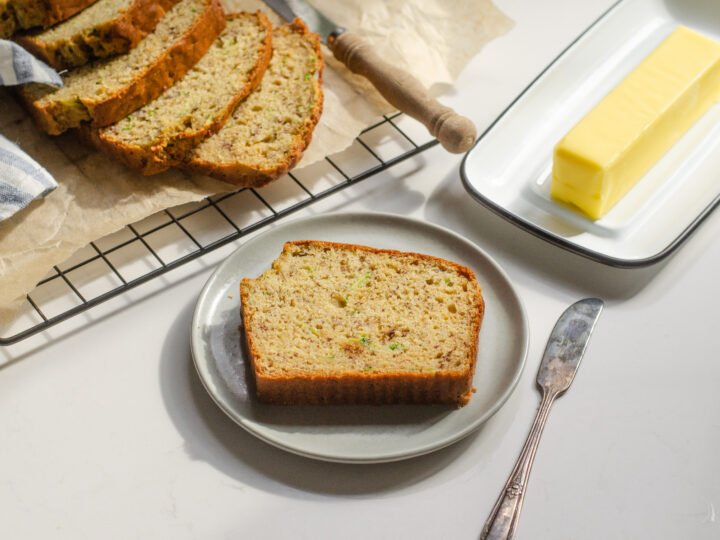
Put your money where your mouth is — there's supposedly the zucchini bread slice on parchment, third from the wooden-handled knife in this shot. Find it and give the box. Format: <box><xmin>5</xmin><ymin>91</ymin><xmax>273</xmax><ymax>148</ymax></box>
<box><xmin>19</xmin><ymin>0</ymin><xmax>225</xmax><ymax>135</ymax></box>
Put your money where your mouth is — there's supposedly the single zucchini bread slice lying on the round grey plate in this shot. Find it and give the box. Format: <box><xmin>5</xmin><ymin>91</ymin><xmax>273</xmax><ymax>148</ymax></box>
<box><xmin>240</xmin><ymin>241</ymin><xmax>484</xmax><ymax>405</ymax></box>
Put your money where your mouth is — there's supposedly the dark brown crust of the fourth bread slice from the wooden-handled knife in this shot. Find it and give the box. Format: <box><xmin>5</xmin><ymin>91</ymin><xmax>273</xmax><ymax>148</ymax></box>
<box><xmin>15</xmin><ymin>0</ymin><xmax>179</xmax><ymax>70</ymax></box>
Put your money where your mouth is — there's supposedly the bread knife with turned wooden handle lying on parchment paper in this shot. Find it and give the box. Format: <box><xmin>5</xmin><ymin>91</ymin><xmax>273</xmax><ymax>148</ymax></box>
<box><xmin>265</xmin><ymin>0</ymin><xmax>477</xmax><ymax>154</ymax></box>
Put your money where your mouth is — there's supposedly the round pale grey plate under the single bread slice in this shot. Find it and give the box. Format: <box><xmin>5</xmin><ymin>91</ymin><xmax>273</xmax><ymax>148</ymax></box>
<box><xmin>192</xmin><ymin>213</ymin><xmax>528</xmax><ymax>463</ymax></box>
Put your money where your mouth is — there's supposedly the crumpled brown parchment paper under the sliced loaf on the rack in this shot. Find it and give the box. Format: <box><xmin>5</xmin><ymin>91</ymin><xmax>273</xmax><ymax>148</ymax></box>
<box><xmin>0</xmin><ymin>0</ymin><xmax>513</xmax><ymax>323</ymax></box>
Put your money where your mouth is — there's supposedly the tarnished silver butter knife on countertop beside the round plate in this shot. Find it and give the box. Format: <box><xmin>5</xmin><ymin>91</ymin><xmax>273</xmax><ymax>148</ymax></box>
<box><xmin>480</xmin><ymin>298</ymin><xmax>604</xmax><ymax>540</ymax></box>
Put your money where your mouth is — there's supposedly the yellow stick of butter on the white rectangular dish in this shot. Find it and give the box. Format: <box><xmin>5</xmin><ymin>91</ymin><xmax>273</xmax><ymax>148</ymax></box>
<box><xmin>551</xmin><ymin>26</ymin><xmax>720</xmax><ymax>219</ymax></box>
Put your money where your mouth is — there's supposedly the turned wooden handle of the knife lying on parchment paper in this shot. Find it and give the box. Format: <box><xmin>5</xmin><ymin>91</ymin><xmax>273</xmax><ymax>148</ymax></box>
<box><xmin>328</xmin><ymin>32</ymin><xmax>477</xmax><ymax>154</ymax></box>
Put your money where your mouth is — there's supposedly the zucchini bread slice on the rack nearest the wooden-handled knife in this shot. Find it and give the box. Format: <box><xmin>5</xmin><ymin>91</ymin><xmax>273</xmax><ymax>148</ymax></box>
<box><xmin>183</xmin><ymin>19</ymin><xmax>323</xmax><ymax>187</ymax></box>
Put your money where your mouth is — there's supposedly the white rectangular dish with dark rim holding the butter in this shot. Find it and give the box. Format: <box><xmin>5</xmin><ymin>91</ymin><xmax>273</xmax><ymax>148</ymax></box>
<box><xmin>461</xmin><ymin>0</ymin><xmax>720</xmax><ymax>267</ymax></box>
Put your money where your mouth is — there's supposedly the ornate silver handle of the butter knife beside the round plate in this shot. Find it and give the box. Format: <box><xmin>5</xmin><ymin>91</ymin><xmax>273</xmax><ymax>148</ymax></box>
<box><xmin>480</xmin><ymin>391</ymin><xmax>558</xmax><ymax>540</ymax></box>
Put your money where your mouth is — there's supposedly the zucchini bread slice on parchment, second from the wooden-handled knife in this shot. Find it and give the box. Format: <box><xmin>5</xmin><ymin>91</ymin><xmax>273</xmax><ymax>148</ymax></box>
<box><xmin>89</xmin><ymin>11</ymin><xmax>272</xmax><ymax>174</ymax></box>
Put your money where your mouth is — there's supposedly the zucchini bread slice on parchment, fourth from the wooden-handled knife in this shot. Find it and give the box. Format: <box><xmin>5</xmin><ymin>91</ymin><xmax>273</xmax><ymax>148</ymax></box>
<box><xmin>15</xmin><ymin>0</ymin><xmax>178</xmax><ymax>69</ymax></box>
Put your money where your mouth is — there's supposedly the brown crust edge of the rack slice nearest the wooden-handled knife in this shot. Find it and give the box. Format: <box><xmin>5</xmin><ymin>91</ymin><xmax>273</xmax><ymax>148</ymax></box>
<box><xmin>180</xmin><ymin>19</ymin><xmax>325</xmax><ymax>188</ymax></box>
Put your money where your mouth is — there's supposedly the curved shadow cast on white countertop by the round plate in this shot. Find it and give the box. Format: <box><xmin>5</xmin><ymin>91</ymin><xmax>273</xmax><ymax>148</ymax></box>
<box><xmin>159</xmin><ymin>300</ymin><xmax>514</xmax><ymax>498</ymax></box>
